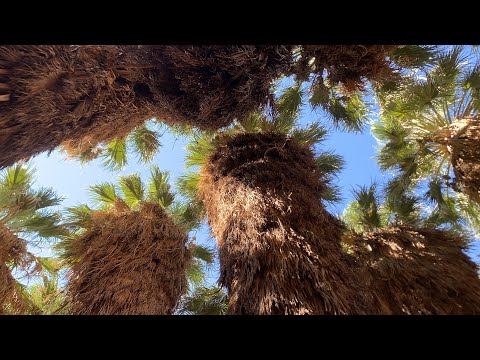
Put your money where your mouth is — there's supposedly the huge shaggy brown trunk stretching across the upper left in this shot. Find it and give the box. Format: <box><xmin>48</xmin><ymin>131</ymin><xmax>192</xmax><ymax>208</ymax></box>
<box><xmin>0</xmin><ymin>45</ymin><xmax>291</xmax><ymax>168</ymax></box>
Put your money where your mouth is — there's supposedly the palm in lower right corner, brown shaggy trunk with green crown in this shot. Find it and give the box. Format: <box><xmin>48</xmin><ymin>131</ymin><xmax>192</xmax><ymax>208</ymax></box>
<box><xmin>343</xmin><ymin>185</ymin><xmax>480</xmax><ymax>315</ymax></box>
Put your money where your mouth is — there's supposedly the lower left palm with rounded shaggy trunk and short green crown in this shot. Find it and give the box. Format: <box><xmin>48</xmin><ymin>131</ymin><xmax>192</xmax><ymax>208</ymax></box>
<box><xmin>57</xmin><ymin>166</ymin><xmax>212</xmax><ymax>314</ymax></box>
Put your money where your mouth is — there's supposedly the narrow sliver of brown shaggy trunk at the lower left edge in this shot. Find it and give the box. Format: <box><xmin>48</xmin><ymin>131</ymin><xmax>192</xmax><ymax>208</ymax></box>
<box><xmin>0</xmin><ymin>223</ymin><xmax>27</xmax><ymax>314</ymax></box>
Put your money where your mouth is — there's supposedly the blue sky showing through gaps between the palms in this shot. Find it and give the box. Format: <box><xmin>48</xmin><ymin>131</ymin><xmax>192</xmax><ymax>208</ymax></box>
<box><xmin>25</xmin><ymin>80</ymin><xmax>480</xmax><ymax>284</ymax></box>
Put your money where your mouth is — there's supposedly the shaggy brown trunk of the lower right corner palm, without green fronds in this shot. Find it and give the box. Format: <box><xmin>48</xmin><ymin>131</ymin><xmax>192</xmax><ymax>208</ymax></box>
<box><xmin>353</xmin><ymin>226</ymin><xmax>480</xmax><ymax>315</ymax></box>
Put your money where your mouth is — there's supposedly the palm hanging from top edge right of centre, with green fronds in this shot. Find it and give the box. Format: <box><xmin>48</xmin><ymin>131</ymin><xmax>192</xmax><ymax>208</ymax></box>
<box><xmin>282</xmin><ymin>45</ymin><xmax>439</xmax><ymax>132</ymax></box>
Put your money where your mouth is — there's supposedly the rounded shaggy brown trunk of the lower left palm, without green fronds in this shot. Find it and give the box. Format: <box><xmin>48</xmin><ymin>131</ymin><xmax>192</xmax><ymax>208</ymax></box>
<box><xmin>68</xmin><ymin>203</ymin><xmax>190</xmax><ymax>315</ymax></box>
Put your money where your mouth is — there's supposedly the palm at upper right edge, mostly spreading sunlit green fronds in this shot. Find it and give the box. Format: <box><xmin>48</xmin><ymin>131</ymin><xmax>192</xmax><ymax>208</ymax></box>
<box><xmin>372</xmin><ymin>47</ymin><xmax>480</xmax><ymax>208</ymax></box>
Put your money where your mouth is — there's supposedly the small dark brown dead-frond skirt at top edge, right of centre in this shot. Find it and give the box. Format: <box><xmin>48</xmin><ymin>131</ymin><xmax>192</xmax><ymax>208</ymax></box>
<box><xmin>296</xmin><ymin>45</ymin><xmax>398</xmax><ymax>91</ymax></box>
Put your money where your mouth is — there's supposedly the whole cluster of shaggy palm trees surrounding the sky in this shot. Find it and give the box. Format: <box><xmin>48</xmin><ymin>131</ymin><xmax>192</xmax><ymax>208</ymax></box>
<box><xmin>0</xmin><ymin>45</ymin><xmax>480</xmax><ymax>315</ymax></box>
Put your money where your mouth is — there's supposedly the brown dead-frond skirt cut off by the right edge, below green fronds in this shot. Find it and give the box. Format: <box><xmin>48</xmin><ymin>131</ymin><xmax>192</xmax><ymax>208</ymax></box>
<box><xmin>449</xmin><ymin>117</ymin><xmax>480</xmax><ymax>204</ymax></box>
